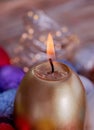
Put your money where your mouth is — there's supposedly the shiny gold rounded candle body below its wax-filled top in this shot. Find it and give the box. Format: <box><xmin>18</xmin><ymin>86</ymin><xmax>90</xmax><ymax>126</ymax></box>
<box><xmin>14</xmin><ymin>64</ymin><xmax>85</xmax><ymax>130</ymax></box>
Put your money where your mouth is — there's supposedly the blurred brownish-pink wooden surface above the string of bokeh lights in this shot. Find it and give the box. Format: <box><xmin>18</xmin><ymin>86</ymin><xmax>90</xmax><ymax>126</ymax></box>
<box><xmin>0</xmin><ymin>0</ymin><xmax>94</xmax><ymax>43</ymax></box>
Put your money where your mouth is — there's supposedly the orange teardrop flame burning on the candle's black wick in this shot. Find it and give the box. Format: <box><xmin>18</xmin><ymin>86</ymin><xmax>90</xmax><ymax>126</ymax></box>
<box><xmin>47</xmin><ymin>33</ymin><xmax>55</xmax><ymax>59</ymax></box>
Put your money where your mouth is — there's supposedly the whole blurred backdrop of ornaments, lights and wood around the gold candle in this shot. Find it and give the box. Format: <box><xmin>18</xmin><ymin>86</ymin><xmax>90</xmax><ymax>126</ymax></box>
<box><xmin>0</xmin><ymin>0</ymin><xmax>94</xmax><ymax>130</ymax></box>
